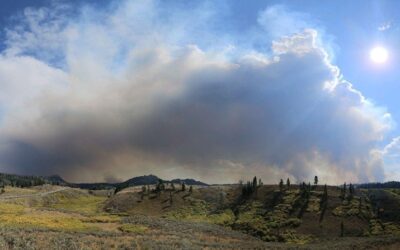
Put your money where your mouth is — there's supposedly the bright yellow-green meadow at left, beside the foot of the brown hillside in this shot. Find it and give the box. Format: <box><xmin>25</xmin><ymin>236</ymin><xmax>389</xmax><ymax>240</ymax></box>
<box><xmin>0</xmin><ymin>188</ymin><xmax>121</xmax><ymax>232</ymax></box>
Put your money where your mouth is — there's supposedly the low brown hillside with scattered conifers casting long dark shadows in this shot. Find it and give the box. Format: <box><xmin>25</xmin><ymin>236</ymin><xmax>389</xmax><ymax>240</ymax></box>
<box><xmin>105</xmin><ymin>179</ymin><xmax>400</xmax><ymax>244</ymax></box>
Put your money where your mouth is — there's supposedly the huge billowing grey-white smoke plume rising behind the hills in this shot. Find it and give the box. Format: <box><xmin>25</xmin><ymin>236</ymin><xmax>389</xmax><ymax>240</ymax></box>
<box><xmin>0</xmin><ymin>1</ymin><xmax>391</xmax><ymax>183</ymax></box>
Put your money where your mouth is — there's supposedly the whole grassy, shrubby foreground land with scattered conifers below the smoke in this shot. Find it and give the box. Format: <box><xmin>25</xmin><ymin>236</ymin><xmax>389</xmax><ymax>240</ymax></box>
<box><xmin>0</xmin><ymin>184</ymin><xmax>400</xmax><ymax>249</ymax></box>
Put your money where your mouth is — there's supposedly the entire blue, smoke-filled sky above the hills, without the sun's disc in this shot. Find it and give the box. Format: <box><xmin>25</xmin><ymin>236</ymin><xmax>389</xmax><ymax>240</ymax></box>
<box><xmin>0</xmin><ymin>0</ymin><xmax>400</xmax><ymax>184</ymax></box>
